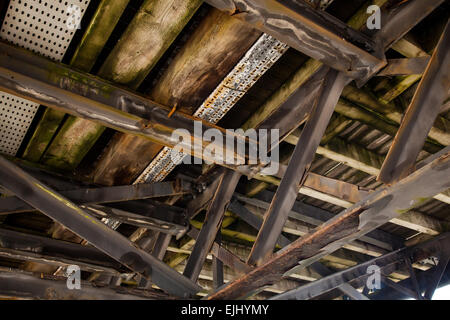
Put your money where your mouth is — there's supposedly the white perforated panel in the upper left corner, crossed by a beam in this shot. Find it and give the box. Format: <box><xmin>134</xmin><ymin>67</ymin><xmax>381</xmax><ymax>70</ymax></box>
<box><xmin>0</xmin><ymin>0</ymin><xmax>90</xmax><ymax>155</ymax></box>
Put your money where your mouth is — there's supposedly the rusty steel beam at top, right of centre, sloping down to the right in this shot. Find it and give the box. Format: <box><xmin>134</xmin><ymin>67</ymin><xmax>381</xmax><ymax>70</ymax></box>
<box><xmin>206</xmin><ymin>0</ymin><xmax>386</xmax><ymax>79</ymax></box>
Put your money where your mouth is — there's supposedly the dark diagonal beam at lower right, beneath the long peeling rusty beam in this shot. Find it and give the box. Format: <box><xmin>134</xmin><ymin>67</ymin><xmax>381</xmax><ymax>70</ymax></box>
<box><xmin>273</xmin><ymin>233</ymin><xmax>450</xmax><ymax>300</ymax></box>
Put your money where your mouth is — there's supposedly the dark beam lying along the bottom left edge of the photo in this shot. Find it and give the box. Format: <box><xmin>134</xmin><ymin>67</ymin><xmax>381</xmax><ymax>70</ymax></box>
<box><xmin>0</xmin><ymin>271</ymin><xmax>173</xmax><ymax>300</ymax></box>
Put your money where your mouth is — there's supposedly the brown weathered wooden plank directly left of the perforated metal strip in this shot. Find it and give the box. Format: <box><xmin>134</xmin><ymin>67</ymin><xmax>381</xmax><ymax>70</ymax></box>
<box><xmin>92</xmin><ymin>8</ymin><xmax>261</xmax><ymax>185</ymax></box>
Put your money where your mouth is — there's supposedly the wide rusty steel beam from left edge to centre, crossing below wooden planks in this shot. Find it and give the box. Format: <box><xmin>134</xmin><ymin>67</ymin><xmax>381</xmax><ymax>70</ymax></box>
<box><xmin>0</xmin><ymin>42</ymin><xmax>258</xmax><ymax>174</ymax></box>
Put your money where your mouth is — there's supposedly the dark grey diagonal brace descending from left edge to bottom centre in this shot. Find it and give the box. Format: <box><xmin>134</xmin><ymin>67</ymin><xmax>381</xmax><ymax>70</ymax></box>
<box><xmin>0</xmin><ymin>156</ymin><xmax>201</xmax><ymax>297</ymax></box>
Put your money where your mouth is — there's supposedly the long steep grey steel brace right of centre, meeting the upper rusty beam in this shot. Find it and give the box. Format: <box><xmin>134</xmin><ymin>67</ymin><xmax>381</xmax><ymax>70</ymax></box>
<box><xmin>248</xmin><ymin>71</ymin><xmax>349</xmax><ymax>265</ymax></box>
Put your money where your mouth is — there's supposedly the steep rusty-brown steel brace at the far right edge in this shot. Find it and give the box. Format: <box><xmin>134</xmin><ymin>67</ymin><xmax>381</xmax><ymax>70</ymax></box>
<box><xmin>378</xmin><ymin>22</ymin><xmax>450</xmax><ymax>183</ymax></box>
